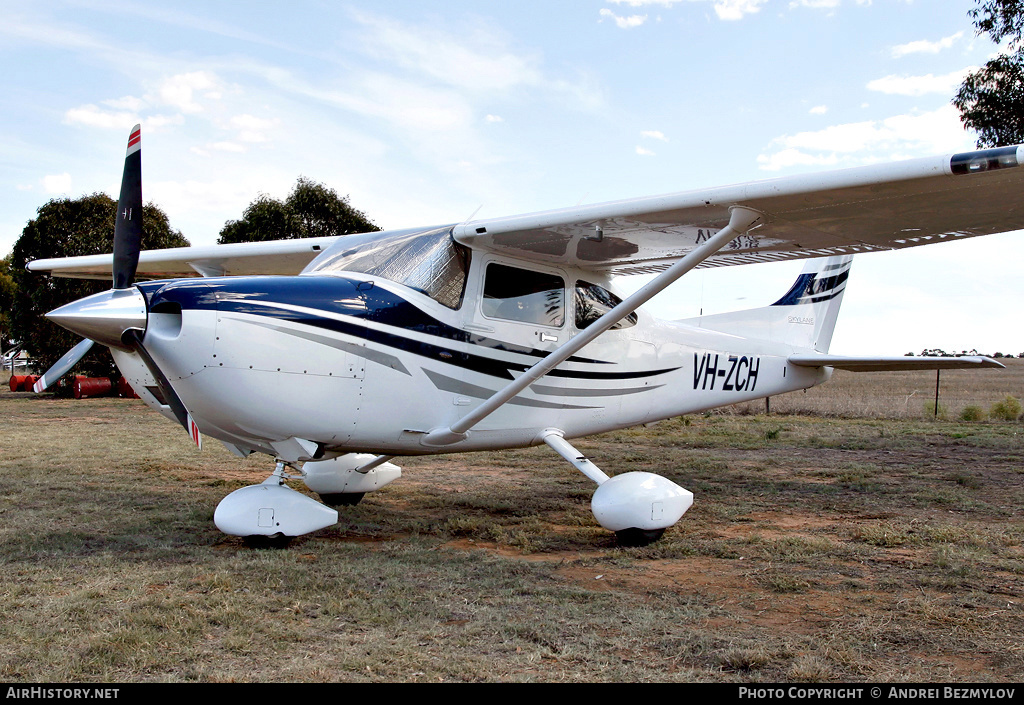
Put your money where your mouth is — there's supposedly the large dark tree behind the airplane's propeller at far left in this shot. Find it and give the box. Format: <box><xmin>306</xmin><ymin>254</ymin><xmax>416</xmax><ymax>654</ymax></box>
<box><xmin>10</xmin><ymin>194</ymin><xmax>188</xmax><ymax>376</ymax></box>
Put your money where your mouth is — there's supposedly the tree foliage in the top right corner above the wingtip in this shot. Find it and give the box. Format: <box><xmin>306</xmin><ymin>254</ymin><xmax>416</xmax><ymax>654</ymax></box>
<box><xmin>953</xmin><ymin>0</ymin><xmax>1024</xmax><ymax>149</ymax></box>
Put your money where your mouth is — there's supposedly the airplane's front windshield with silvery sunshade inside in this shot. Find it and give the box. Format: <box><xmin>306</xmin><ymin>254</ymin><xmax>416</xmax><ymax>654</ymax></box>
<box><xmin>303</xmin><ymin>225</ymin><xmax>469</xmax><ymax>308</ymax></box>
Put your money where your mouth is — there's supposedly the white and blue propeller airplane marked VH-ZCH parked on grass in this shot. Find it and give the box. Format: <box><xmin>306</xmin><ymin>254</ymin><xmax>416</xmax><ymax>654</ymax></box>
<box><xmin>29</xmin><ymin>126</ymin><xmax>1024</xmax><ymax>544</ymax></box>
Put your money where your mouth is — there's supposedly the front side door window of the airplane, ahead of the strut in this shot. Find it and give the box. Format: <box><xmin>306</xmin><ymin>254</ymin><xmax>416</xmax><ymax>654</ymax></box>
<box><xmin>480</xmin><ymin>262</ymin><xmax>565</xmax><ymax>328</ymax></box>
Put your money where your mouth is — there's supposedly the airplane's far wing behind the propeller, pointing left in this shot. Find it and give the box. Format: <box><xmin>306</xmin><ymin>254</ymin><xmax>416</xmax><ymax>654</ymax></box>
<box><xmin>28</xmin><ymin>237</ymin><xmax>338</xmax><ymax>279</ymax></box>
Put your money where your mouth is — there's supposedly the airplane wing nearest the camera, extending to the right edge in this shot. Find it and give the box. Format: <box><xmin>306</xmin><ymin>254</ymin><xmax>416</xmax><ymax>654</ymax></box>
<box><xmin>455</xmin><ymin>147</ymin><xmax>1024</xmax><ymax>275</ymax></box>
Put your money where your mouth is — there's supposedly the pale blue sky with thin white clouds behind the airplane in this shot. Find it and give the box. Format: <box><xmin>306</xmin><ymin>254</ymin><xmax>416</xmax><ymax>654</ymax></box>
<box><xmin>0</xmin><ymin>0</ymin><xmax>1024</xmax><ymax>355</ymax></box>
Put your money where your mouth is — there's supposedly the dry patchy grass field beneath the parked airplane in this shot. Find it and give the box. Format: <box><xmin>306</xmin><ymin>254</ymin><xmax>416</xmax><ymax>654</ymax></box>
<box><xmin>0</xmin><ymin>361</ymin><xmax>1024</xmax><ymax>681</ymax></box>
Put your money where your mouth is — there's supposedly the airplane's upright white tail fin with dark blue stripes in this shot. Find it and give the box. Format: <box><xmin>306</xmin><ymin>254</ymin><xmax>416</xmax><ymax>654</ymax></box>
<box><xmin>681</xmin><ymin>255</ymin><xmax>853</xmax><ymax>353</ymax></box>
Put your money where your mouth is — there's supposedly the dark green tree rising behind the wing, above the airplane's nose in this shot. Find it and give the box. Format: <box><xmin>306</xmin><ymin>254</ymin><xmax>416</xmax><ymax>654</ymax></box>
<box><xmin>217</xmin><ymin>176</ymin><xmax>380</xmax><ymax>245</ymax></box>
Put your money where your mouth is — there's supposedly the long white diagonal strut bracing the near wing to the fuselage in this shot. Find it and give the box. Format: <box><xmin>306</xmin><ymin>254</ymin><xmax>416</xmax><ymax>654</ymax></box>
<box><xmin>421</xmin><ymin>206</ymin><xmax>763</xmax><ymax>446</ymax></box>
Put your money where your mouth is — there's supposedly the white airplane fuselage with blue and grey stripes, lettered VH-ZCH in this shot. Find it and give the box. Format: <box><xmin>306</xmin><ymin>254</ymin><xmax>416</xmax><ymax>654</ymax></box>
<box><xmin>112</xmin><ymin>240</ymin><xmax>827</xmax><ymax>455</ymax></box>
